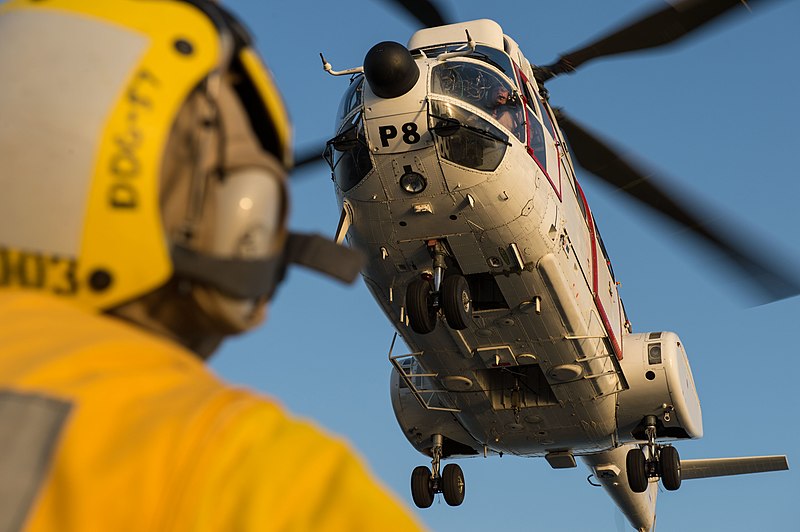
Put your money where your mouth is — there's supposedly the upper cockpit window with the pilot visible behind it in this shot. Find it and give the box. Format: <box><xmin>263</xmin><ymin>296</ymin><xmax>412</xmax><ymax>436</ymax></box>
<box><xmin>431</xmin><ymin>61</ymin><xmax>525</xmax><ymax>142</ymax></box>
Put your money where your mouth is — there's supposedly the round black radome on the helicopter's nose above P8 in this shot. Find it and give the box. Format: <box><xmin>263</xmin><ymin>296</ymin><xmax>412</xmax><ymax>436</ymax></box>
<box><xmin>364</xmin><ymin>41</ymin><xmax>419</xmax><ymax>98</ymax></box>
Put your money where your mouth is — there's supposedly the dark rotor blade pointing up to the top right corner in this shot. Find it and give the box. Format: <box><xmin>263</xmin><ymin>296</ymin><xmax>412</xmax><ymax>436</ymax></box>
<box><xmin>536</xmin><ymin>0</ymin><xmax>780</xmax><ymax>82</ymax></box>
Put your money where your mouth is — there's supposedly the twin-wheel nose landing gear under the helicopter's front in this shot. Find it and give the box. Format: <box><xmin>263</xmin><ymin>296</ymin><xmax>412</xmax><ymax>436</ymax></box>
<box><xmin>406</xmin><ymin>240</ymin><xmax>472</xmax><ymax>334</ymax></box>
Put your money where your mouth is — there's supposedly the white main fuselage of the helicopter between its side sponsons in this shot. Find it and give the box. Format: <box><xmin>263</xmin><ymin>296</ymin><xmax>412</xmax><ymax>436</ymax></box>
<box><xmin>334</xmin><ymin>17</ymin><xmax>699</xmax><ymax>462</ymax></box>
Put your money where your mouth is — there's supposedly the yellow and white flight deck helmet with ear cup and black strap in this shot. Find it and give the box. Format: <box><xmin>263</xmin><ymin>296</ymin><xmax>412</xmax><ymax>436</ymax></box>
<box><xmin>0</xmin><ymin>0</ymin><xmax>361</xmax><ymax>310</ymax></box>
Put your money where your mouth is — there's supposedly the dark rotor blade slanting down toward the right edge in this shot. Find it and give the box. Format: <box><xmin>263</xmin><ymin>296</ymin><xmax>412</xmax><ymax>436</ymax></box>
<box><xmin>554</xmin><ymin>109</ymin><xmax>800</xmax><ymax>301</ymax></box>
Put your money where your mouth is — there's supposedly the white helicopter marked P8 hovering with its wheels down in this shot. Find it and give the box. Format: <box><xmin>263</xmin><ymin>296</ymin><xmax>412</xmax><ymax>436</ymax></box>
<box><xmin>276</xmin><ymin>2</ymin><xmax>797</xmax><ymax>529</ymax></box>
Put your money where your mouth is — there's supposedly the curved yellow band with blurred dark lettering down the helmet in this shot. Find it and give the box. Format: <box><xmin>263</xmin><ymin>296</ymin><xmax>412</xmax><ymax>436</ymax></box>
<box><xmin>78</xmin><ymin>1</ymin><xmax>220</xmax><ymax>308</ymax></box>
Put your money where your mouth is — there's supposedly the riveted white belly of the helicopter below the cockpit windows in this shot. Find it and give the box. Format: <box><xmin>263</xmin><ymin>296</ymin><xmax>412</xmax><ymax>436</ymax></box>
<box><xmin>346</xmin><ymin>138</ymin><xmax>625</xmax><ymax>455</ymax></box>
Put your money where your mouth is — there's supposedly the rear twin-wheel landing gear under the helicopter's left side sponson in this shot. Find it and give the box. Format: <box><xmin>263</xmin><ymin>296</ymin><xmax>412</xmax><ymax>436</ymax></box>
<box><xmin>411</xmin><ymin>434</ymin><xmax>465</xmax><ymax>508</ymax></box>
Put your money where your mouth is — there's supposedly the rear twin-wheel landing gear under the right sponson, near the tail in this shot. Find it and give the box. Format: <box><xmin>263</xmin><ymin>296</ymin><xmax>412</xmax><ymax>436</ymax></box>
<box><xmin>625</xmin><ymin>416</ymin><xmax>681</xmax><ymax>493</ymax></box>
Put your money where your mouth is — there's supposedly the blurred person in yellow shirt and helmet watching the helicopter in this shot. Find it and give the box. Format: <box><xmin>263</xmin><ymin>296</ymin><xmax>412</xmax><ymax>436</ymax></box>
<box><xmin>0</xmin><ymin>0</ymin><xmax>424</xmax><ymax>531</ymax></box>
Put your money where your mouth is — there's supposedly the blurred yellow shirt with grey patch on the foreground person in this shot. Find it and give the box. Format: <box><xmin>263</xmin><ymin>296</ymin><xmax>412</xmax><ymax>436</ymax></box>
<box><xmin>0</xmin><ymin>293</ymin><xmax>419</xmax><ymax>532</ymax></box>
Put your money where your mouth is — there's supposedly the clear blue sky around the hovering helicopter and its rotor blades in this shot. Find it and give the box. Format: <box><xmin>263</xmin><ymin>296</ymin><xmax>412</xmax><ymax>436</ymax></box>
<box><xmin>213</xmin><ymin>0</ymin><xmax>800</xmax><ymax>532</ymax></box>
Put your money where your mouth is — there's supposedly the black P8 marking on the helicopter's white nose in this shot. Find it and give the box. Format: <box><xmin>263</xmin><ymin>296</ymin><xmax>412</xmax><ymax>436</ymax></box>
<box><xmin>367</xmin><ymin>113</ymin><xmax>433</xmax><ymax>153</ymax></box>
